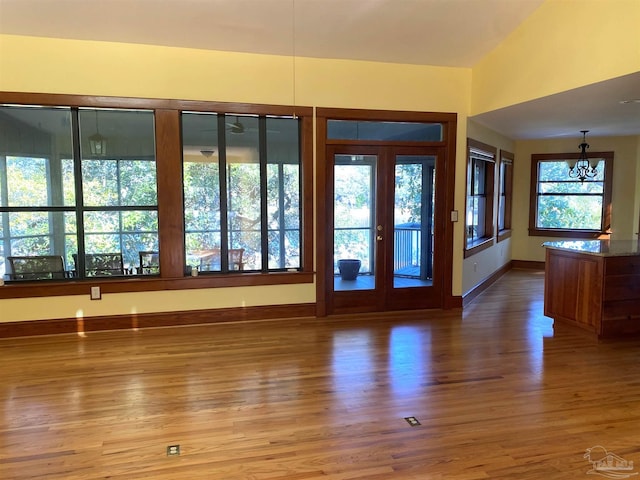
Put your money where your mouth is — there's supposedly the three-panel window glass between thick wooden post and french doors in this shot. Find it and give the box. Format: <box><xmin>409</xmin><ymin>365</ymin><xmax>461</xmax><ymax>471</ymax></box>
<box><xmin>182</xmin><ymin>112</ymin><xmax>302</xmax><ymax>273</ymax></box>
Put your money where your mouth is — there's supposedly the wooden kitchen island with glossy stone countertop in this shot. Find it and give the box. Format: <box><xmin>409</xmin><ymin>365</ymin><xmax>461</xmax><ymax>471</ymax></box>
<box><xmin>543</xmin><ymin>240</ymin><xmax>640</xmax><ymax>338</ymax></box>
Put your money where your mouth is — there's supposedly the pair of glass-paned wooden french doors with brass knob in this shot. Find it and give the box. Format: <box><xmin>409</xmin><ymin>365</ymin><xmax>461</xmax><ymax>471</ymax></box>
<box><xmin>325</xmin><ymin>145</ymin><xmax>450</xmax><ymax>313</ymax></box>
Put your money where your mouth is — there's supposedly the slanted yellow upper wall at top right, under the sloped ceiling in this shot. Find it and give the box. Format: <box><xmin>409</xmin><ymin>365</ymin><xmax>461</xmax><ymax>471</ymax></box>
<box><xmin>471</xmin><ymin>0</ymin><xmax>640</xmax><ymax>115</ymax></box>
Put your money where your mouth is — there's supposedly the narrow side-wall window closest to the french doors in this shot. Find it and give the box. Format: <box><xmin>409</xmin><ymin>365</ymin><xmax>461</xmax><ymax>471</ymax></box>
<box><xmin>465</xmin><ymin>139</ymin><xmax>496</xmax><ymax>256</ymax></box>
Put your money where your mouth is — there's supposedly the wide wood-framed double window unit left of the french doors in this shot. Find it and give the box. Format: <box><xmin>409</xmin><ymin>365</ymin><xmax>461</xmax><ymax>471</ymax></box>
<box><xmin>0</xmin><ymin>92</ymin><xmax>314</xmax><ymax>292</ymax></box>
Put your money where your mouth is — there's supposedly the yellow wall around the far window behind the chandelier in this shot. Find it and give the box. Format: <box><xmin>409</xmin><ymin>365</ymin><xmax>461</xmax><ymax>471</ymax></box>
<box><xmin>512</xmin><ymin>136</ymin><xmax>640</xmax><ymax>261</ymax></box>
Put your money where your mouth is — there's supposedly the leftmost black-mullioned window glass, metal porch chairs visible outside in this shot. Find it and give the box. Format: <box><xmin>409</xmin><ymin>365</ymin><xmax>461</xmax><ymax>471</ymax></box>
<box><xmin>0</xmin><ymin>106</ymin><xmax>158</xmax><ymax>281</ymax></box>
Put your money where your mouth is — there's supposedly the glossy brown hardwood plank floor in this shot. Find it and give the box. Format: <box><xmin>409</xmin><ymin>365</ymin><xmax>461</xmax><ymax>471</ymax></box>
<box><xmin>0</xmin><ymin>270</ymin><xmax>640</xmax><ymax>480</ymax></box>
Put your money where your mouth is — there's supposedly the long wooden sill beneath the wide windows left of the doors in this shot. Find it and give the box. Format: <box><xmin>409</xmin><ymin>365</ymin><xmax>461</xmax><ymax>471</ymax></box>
<box><xmin>0</xmin><ymin>272</ymin><xmax>315</xmax><ymax>299</ymax></box>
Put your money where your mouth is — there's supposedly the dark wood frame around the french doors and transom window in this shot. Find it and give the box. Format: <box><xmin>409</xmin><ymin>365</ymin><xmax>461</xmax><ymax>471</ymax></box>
<box><xmin>315</xmin><ymin>108</ymin><xmax>460</xmax><ymax>317</ymax></box>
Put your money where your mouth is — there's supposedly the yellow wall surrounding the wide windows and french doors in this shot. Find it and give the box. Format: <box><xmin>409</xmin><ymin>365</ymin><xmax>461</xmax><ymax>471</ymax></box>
<box><xmin>0</xmin><ymin>35</ymin><xmax>471</xmax><ymax>322</ymax></box>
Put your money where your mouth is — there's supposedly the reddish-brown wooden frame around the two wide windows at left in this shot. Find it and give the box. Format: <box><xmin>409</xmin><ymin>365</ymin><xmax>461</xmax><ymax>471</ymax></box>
<box><xmin>0</xmin><ymin>92</ymin><xmax>315</xmax><ymax>299</ymax></box>
